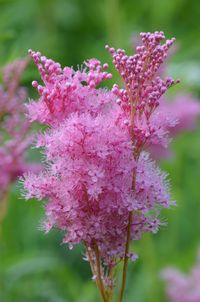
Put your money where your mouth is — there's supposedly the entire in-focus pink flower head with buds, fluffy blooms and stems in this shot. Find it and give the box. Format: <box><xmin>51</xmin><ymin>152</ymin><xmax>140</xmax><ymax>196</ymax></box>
<box><xmin>23</xmin><ymin>32</ymin><xmax>177</xmax><ymax>302</ymax></box>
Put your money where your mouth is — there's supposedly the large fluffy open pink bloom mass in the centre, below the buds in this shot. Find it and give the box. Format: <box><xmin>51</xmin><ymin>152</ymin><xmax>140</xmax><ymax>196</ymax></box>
<box><xmin>24</xmin><ymin>113</ymin><xmax>170</xmax><ymax>262</ymax></box>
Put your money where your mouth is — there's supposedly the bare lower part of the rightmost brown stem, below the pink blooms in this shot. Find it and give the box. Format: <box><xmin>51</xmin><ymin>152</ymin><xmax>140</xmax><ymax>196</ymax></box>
<box><xmin>118</xmin><ymin>212</ymin><xmax>133</xmax><ymax>302</ymax></box>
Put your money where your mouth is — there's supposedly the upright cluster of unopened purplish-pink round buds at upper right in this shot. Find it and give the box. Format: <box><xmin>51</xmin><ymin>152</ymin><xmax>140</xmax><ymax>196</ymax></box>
<box><xmin>106</xmin><ymin>32</ymin><xmax>175</xmax><ymax>107</ymax></box>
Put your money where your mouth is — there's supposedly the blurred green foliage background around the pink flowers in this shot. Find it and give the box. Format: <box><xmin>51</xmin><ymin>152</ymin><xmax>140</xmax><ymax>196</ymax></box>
<box><xmin>0</xmin><ymin>0</ymin><xmax>200</xmax><ymax>302</ymax></box>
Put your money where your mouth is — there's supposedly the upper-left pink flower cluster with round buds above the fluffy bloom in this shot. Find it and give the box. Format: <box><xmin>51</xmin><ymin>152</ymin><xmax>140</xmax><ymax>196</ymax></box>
<box><xmin>28</xmin><ymin>50</ymin><xmax>113</xmax><ymax>125</ymax></box>
